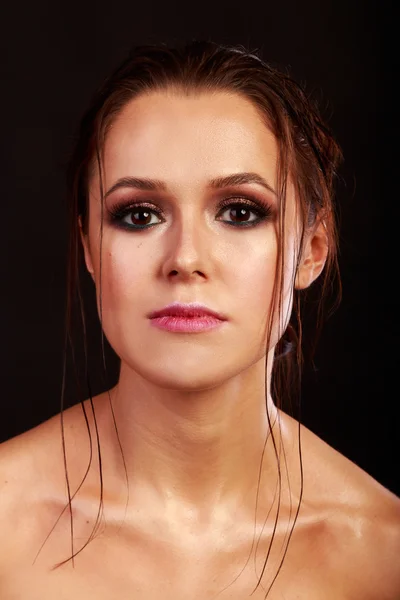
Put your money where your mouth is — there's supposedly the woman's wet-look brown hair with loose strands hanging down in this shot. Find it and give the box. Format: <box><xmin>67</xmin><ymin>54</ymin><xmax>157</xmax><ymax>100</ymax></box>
<box><xmin>34</xmin><ymin>40</ymin><xmax>341</xmax><ymax>597</ymax></box>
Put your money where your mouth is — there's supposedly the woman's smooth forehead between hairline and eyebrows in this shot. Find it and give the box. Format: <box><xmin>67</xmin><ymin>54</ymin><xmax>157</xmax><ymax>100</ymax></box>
<box><xmin>100</xmin><ymin>91</ymin><xmax>277</xmax><ymax>187</ymax></box>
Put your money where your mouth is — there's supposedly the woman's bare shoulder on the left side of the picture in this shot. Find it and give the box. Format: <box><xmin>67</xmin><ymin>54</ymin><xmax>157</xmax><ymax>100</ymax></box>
<box><xmin>0</xmin><ymin>406</ymin><xmax>95</xmax><ymax>576</ymax></box>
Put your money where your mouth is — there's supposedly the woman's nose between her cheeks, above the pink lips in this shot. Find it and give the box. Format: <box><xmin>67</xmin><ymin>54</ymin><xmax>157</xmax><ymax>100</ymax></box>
<box><xmin>163</xmin><ymin>211</ymin><xmax>210</xmax><ymax>280</ymax></box>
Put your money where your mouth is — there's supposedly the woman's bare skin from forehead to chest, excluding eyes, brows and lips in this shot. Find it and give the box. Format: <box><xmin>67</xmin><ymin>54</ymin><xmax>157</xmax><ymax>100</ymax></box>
<box><xmin>0</xmin><ymin>91</ymin><xmax>400</xmax><ymax>600</ymax></box>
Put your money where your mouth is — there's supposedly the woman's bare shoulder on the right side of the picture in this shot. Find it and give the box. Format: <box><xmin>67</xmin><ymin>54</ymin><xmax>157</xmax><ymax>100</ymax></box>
<box><xmin>290</xmin><ymin>418</ymin><xmax>400</xmax><ymax>600</ymax></box>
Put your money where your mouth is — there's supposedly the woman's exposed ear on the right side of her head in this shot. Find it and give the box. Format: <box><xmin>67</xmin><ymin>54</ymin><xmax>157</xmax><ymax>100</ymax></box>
<box><xmin>295</xmin><ymin>220</ymin><xmax>328</xmax><ymax>290</ymax></box>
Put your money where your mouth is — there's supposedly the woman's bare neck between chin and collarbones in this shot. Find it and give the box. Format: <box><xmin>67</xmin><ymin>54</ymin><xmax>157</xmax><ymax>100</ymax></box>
<box><xmin>88</xmin><ymin>357</ymin><xmax>279</xmax><ymax>511</ymax></box>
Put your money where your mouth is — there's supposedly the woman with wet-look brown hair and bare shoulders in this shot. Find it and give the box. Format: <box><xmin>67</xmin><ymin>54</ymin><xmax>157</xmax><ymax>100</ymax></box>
<box><xmin>0</xmin><ymin>42</ymin><xmax>400</xmax><ymax>600</ymax></box>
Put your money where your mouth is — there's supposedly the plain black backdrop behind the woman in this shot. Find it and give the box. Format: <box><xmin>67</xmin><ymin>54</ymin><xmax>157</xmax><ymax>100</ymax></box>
<box><xmin>0</xmin><ymin>0</ymin><xmax>400</xmax><ymax>494</ymax></box>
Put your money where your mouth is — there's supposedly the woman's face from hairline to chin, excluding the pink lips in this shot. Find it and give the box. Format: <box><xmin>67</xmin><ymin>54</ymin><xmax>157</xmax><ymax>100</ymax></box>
<box><xmin>84</xmin><ymin>92</ymin><xmax>304</xmax><ymax>390</ymax></box>
